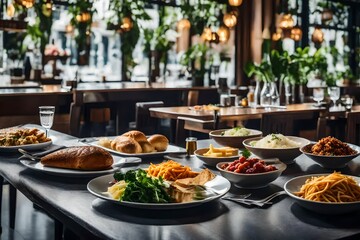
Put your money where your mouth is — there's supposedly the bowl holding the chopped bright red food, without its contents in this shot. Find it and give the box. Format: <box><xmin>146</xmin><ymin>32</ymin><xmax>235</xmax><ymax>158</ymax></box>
<box><xmin>216</xmin><ymin>159</ymin><xmax>286</xmax><ymax>189</ymax></box>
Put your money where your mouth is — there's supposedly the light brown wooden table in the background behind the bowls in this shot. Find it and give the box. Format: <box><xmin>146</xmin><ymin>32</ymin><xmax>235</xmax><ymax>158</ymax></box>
<box><xmin>150</xmin><ymin>103</ymin><xmax>326</xmax><ymax>144</ymax></box>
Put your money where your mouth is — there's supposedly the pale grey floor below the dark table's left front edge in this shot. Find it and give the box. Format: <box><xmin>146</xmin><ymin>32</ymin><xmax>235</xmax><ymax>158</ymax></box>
<box><xmin>0</xmin><ymin>185</ymin><xmax>54</xmax><ymax>240</ymax></box>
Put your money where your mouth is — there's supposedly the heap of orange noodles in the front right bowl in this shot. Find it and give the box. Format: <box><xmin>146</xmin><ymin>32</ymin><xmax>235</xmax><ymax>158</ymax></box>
<box><xmin>295</xmin><ymin>172</ymin><xmax>360</xmax><ymax>203</ymax></box>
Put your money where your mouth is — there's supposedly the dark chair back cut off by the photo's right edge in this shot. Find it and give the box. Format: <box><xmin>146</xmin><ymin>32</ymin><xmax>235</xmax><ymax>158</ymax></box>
<box><xmin>346</xmin><ymin>111</ymin><xmax>360</xmax><ymax>145</ymax></box>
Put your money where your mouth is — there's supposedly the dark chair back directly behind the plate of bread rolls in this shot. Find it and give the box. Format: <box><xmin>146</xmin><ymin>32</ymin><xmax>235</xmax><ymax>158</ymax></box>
<box><xmin>135</xmin><ymin>101</ymin><xmax>164</xmax><ymax>134</ymax></box>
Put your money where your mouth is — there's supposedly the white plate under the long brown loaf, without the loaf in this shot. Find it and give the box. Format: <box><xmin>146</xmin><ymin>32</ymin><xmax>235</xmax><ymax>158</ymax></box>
<box><xmin>20</xmin><ymin>159</ymin><xmax>124</xmax><ymax>177</ymax></box>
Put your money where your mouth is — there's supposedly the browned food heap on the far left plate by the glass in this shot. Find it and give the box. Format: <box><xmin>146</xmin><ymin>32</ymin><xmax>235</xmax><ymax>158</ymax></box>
<box><xmin>0</xmin><ymin>128</ymin><xmax>51</xmax><ymax>147</ymax></box>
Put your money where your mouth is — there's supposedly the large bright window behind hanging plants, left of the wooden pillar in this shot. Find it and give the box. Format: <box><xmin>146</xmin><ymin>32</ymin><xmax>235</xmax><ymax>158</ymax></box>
<box><xmin>0</xmin><ymin>0</ymin><xmax>236</xmax><ymax>85</ymax></box>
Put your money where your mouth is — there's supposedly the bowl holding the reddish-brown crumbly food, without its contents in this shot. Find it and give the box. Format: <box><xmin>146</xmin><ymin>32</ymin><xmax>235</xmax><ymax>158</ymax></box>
<box><xmin>300</xmin><ymin>143</ymin><xmax>360</xmax><ymax>169</ymax></box>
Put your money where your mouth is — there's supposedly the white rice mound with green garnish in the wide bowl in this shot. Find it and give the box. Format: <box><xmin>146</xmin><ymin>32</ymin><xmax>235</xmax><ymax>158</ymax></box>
<box><xmin>250</xmin><ymin>133</ymin><xmax>301</xmax><ymax>148</ymax></box>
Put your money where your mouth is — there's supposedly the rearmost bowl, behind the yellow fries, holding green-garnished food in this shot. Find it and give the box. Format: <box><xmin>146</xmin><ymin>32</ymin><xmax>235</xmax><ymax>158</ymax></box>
<box><xmin>209</xmin><ymin>129</ymin><xmax>262</xmax><ymax>148</ymax></box>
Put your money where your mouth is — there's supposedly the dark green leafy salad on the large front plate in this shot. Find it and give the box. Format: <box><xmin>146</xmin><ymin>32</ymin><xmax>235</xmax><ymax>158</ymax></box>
<box><xmin>114</xmin><ymin>169</ymin><xmax>171</xmax><ymax>203</ymax></box>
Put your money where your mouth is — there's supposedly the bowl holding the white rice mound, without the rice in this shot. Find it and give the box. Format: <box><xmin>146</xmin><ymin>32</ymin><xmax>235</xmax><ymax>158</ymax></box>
<box><xmin>243</xmin><ymin>136</ymin><xmax>310</xmax><ymax>164</ymax></box>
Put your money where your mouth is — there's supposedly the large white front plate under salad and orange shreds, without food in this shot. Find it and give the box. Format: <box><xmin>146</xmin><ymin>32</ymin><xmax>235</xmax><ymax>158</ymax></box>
<box><xmin>87</xmin><ymin>174</ymin><xmax>231</xmax><ymax>210</ymax></box>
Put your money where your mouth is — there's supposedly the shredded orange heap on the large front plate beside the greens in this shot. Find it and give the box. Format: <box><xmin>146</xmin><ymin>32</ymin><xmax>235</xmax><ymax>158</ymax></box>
<box><xmin>147</xmin><ymin>160</ymin><xmax>198</xmax><ymax>181</ymax></box>
